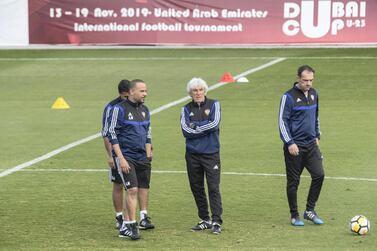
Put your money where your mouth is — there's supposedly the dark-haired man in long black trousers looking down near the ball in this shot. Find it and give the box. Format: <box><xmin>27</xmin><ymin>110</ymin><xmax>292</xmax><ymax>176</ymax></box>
<box><xmin>279</xmin><ymin>65</ymin><xmax>324</xmax><ymax>226</ymax></box>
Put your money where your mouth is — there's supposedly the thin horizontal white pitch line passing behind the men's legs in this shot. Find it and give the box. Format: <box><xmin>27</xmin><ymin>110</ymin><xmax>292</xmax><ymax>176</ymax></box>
<box><xmin>10</xmin><ymin>168</ymin><xmax>377</xmax><ymax>182</ymax></box>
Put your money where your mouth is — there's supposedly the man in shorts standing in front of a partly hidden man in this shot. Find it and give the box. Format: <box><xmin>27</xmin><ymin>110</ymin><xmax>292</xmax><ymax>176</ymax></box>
<box><xmin>108</xmin><ymin>79</ymin><xmax>154</xmax><ymax>240</ymax></box>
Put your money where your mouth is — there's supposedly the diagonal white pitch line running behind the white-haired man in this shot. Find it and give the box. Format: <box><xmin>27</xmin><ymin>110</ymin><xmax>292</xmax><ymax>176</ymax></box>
<box><xmin>0</xmin><ymin>58</ymin><xmax>285</xmax><ymax>178</ymax></box>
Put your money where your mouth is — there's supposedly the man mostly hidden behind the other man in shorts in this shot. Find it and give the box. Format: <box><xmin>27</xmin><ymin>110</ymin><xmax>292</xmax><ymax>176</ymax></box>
<box><xmin>101</xmin><ymin>79</ymin><xmax>130</xmax><ymax>229</ymax></box>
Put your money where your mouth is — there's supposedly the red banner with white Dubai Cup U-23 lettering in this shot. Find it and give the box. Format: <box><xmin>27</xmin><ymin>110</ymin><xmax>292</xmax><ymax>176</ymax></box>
<box><xmin>29</xmin><ymin>0</ymin><xmax>377</xmax><ymax>45</ymax></box>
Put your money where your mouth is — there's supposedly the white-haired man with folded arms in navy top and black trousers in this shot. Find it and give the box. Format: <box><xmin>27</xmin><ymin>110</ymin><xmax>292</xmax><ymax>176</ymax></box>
<box><xmin>181</xmin><ymin>78</ymin><xmax>222</xmax><ymax>234</ymax></box>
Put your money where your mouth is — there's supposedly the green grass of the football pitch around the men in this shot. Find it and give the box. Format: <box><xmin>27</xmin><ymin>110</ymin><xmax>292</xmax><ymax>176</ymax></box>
<box><xmin>0</xmin><ymin>49</ymin><xmax>377</xmax><ymax>250</ymax></box>
